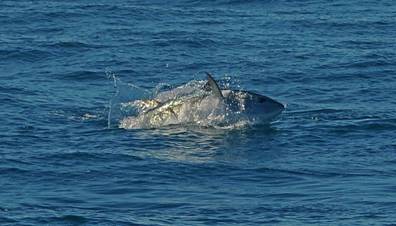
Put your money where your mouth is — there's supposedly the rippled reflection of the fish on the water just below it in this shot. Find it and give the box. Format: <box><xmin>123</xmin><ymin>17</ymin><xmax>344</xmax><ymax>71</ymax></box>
<box><xmin>125</xmin><ymin>125</ymin><xmax>280</xmax><ymax>164</ymax></box>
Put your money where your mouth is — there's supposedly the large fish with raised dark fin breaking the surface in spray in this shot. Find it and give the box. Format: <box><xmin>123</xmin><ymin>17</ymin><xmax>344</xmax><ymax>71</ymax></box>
<box><xmin>119</xmin><ymin>72</ymin><xmax>285</xmax><ymax>128</ymax></box>
